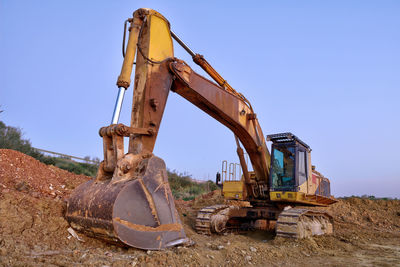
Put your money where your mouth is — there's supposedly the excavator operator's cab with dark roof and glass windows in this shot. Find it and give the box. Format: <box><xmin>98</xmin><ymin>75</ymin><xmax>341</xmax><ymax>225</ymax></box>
<box><xmin>267</xmin><ymin>133</ymin><xmax>311</xmax><ymax>192</ymax></box>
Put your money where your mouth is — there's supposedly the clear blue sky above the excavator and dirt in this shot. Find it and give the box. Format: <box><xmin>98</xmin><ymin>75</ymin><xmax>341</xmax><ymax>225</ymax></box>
<box><xmin>0</xmin><ymin>0</ymin><xmax>400</xmax><ymax>197</ymax></box>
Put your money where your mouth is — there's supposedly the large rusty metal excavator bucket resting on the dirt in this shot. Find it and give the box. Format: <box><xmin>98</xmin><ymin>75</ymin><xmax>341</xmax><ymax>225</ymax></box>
<box><xmin>66</xmin><ymin>156</ymin><xmax>189</xmax><ymax>250</ymax></box>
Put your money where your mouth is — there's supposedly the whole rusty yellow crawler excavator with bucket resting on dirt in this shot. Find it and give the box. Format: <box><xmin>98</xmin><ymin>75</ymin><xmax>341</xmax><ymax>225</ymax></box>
<box><xmin>65</xmin><ymin>8</ymin><xmax>336</xmax><ymax>250</ymax></box>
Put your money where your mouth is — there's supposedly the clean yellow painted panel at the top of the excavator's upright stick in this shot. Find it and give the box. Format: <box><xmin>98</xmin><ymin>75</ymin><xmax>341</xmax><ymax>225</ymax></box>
<box><xmin>148</xmin><ymin>15</ymin><xmax>174</xmax><ymax>61</ymax></box>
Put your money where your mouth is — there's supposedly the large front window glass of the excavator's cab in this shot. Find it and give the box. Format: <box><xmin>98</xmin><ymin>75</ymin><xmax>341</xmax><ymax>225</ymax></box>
<box><xmin>271</xmin><ymin>146</ymin><xmax>296</xmax><ymax>190</ymax></box>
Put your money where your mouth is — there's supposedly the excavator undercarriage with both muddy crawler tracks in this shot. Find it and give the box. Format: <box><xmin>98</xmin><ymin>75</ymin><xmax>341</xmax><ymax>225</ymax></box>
<box><xmin>196</xmin><ymin>202</ymin><xmax>333</xmax><ymax>238</ymax></box>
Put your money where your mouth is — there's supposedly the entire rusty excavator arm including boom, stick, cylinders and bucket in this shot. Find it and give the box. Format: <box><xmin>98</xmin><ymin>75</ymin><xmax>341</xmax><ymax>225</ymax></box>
<box><xmin>66</xmin><ymin>9</ymin><xmax>270</xmax><ymax>249</ymax></box>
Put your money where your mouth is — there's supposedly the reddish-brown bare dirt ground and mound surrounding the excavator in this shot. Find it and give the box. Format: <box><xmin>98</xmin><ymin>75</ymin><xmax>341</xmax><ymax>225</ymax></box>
<box><xmin>0</xmin><ymin>150</ymin><xmax>400</xmax><ymax>266</ymax></box>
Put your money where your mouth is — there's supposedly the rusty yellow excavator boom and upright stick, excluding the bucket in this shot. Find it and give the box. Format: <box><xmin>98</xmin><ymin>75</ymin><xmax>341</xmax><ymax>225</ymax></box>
<box><xmin>117</xmin><ymin>9</ymin><xmax>270</xmax><ymax>191</ymax></box>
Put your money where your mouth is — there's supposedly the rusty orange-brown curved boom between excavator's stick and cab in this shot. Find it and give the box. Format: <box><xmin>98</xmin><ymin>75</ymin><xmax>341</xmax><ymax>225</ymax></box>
<box><xmin>170</xmin><ymin>61</ymin><xmax>270</xmax><ymax>193</ymax></box>
